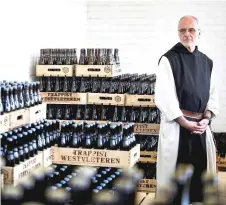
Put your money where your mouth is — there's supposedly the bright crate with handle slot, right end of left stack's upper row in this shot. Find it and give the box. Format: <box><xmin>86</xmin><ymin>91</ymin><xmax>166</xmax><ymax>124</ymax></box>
<box><xmin>28</xmin><ymin>103</ymin><xmax>46</xmax><ymax>123</ymax></box>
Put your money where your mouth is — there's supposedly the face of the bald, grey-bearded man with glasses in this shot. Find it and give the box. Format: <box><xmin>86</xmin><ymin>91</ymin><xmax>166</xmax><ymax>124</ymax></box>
<box><xmin>178</xmin><ymin>17</ymin><xmax>200</xmax><ymax>47</ymax></box>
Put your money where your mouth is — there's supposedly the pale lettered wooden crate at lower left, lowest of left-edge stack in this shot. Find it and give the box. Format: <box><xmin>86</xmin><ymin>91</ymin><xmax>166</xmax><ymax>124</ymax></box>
<box><xmin>2</xmin><ymin>154</ymin><xmax>43</xmax><ymax>186</ymax></box>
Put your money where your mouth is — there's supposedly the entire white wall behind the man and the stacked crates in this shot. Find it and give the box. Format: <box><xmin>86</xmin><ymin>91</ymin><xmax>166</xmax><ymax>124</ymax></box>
<box><xmin>0</xmin><ymin>0</ymin><xmax>226</xmax><ymax>131</ymax></box>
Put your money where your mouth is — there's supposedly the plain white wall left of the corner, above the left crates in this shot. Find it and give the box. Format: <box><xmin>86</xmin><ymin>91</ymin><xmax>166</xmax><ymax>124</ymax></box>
<box><xmin>0</xmin><ymin>0</ymin><xmax>87</xmax><ymax>80</ymax></box>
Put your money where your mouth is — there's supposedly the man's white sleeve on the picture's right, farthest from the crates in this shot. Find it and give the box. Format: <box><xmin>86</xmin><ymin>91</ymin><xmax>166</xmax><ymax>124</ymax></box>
<box><xmin>206</xmin><ymin>69</ymin><xmax>219</xmax><ymax>117</ymax></box>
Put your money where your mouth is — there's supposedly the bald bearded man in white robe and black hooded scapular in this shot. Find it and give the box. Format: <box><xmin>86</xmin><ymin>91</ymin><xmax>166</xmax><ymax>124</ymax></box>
<box><xmin>155</xmin><ymin>16</ymin><xmax>218</xmax><ymax>202</ymax></box>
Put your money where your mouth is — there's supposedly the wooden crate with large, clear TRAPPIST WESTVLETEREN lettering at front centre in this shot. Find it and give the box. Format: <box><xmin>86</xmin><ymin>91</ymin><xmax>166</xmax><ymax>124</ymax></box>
<box><xmin>53</xmin><ymin>144</ymin><xmax>140</xmax><ymax>168</ymax></box>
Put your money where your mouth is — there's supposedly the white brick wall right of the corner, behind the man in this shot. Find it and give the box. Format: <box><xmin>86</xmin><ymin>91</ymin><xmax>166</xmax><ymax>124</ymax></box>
<box><xmin>87</xmin><ymin>0</ymin><xmax>226</xmax><ymax>132</ymax></box>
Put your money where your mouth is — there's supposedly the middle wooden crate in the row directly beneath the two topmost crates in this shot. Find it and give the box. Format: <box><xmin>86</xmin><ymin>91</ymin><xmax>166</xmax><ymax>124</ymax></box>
<box><xmin>87</xmin><ymin>93</ymin><xmax>125</xmax><ymax>106</ymax></box>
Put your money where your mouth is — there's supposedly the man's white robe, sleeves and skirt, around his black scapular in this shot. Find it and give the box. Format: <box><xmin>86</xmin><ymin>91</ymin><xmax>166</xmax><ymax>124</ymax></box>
<box><xmin>155</xmin><ymin>56</ymin><xmax>219</xmax><ymax>194</ymax></box>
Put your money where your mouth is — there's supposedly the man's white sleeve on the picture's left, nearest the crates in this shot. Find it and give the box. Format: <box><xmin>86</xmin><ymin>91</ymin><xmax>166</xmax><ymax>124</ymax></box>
<box><xmin>155</xmin><ymin>56</ymin><xmax>183</xmax><ymax>121</ymax></box>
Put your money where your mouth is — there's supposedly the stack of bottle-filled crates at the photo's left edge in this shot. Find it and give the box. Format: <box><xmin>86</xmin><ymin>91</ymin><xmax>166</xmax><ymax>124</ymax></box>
<box><xmin>0</xmin><ymin>81</ymin><xmax>46</xmax><ymax>185</ymax></box>
